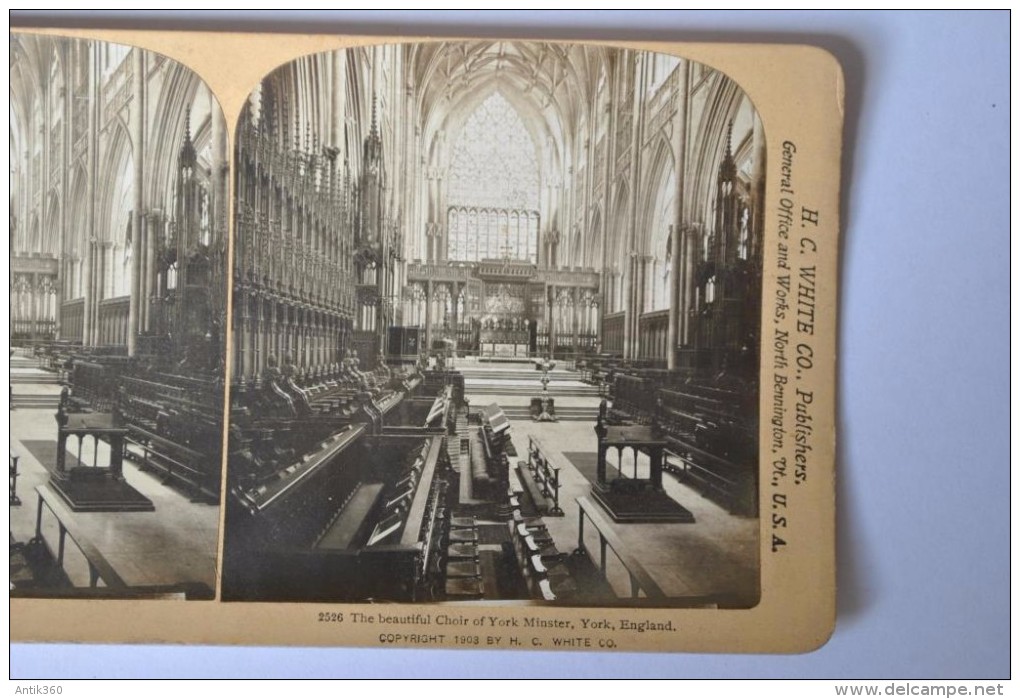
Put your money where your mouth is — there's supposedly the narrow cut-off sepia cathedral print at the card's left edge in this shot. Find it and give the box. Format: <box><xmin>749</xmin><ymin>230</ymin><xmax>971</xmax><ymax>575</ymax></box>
<box><xmin>8</xmin><ymin>34</ymin><xmax>228</xmax><ymax>600</ymax></box>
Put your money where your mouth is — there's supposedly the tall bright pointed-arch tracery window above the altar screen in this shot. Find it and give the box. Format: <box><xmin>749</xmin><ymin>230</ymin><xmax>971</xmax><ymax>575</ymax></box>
<box><xmin>447</xmin><ymin>92</ymin><xmax>540</xmax><ymax>262</ymax></box>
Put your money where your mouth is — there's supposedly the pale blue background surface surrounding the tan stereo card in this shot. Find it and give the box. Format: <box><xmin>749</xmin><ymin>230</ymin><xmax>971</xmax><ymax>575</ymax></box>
<box><xmin>10</xmin><ymin>10</ymin><xmax>1010</xmax><ymax>678</ymax></box>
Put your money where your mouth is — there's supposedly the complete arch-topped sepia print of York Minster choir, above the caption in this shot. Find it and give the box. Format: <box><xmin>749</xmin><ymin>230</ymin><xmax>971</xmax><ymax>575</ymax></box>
<box><xmin>220</xmin><ymin>41</ymin><xmax>766</xmax><ymax>604</ymax></box>
